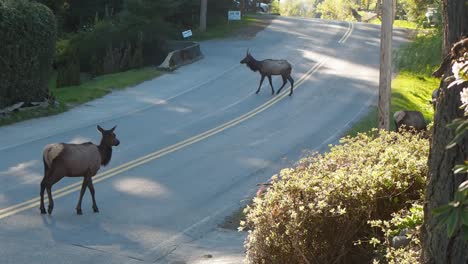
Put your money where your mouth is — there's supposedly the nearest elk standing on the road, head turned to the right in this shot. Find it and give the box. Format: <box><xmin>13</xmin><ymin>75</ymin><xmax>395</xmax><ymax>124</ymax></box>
<box><xmin>39</xmin><ymin>125</ymin><xmax>120</xmax><ymax>215</ymax></box>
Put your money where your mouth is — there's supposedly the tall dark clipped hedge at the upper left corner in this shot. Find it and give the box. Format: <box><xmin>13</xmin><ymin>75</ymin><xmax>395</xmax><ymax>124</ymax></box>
<box><xmin>0</xmin><ymin>1</ymin><xmax>56</xmax><ymax>107</ymax></box>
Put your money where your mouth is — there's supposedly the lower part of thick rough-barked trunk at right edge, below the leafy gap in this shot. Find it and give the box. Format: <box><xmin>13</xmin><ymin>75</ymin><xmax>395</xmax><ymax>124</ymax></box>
<box><xmin>421</xmin><ymin>77</ymin><xmax>468</xmax><ymax>264</ymax></box>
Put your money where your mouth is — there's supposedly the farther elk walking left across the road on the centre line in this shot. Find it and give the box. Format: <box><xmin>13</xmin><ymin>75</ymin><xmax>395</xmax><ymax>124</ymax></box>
<box><xmin>240</xmin><ymin>50</ymin><xmax>294</xmax><ymax>96</ymax></box>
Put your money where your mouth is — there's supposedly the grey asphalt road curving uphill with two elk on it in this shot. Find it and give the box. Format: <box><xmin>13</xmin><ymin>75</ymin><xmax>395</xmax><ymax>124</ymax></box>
<box><xmin>0</xmin><ymin>18</ymin><xmax>407</xmax><ymax>264</ymax></box>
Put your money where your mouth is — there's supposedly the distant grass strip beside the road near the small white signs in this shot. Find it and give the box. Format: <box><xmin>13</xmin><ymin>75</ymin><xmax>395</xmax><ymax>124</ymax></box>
<box><xmin>193</xmin><ymin>15</ymin><xmax>261</xmax><ymax>41</ymax></box>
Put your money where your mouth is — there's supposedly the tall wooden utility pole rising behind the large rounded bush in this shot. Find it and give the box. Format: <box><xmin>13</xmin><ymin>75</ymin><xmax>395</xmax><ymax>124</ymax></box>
<box><xmin>379</xmin><ymin>0</ymin><xmax>395</xmax><ymax>131</ymax></box>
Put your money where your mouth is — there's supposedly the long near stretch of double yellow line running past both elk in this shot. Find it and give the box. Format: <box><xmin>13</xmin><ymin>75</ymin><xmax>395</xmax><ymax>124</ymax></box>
<box><xmin>0</xmin><ymin>59</ymin><xmax>325</xmax><ymax>219</ymax></box>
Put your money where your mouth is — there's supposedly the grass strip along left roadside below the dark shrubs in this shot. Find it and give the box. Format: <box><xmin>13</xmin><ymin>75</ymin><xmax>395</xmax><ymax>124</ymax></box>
<box><xmin>0</xmin><ymin>67</ymin><xmax>161</xmax><ymax>126</ymax></box>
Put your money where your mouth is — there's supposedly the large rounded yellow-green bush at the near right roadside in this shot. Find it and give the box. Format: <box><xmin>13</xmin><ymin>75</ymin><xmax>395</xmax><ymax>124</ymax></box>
<box><xmin>241</xmin><ymin>130</ymin><xmax>429</xmax><ymax>264</ymax></box>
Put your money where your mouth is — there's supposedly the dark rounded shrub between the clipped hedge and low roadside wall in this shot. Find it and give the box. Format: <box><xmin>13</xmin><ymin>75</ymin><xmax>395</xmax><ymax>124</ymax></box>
<box><xmin>60</xmin><ymin>19</ymin><xmax>166</xmax><ymax>76</ymax></box>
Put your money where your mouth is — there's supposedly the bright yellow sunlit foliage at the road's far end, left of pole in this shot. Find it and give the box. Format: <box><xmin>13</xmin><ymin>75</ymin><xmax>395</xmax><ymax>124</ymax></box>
<box><xmin>317</xmin><ymin>0</ymin><xmax>358</xmax><ymax>21</ymax></box>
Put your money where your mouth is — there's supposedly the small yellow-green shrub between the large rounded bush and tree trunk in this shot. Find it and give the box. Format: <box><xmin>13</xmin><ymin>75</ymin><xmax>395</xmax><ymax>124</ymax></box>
<box><xmin>369</xmin><ymin>203</ymin><xmax>424</xmax><ymax>264</ymax></box>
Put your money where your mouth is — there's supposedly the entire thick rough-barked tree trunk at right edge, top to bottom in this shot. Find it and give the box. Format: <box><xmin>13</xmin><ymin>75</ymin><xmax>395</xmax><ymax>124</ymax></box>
<box><xmin>422</xmin><ymin>0</ymin><xmax>468</xmax><ymax>264</ymax></box>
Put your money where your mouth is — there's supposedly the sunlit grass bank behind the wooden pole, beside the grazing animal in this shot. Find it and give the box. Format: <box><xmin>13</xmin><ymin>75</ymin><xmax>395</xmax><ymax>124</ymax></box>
<box><xmin>346</xmin><ymin>31</ymin><xmax>442</xmax><ymax>136</ymax></box>
